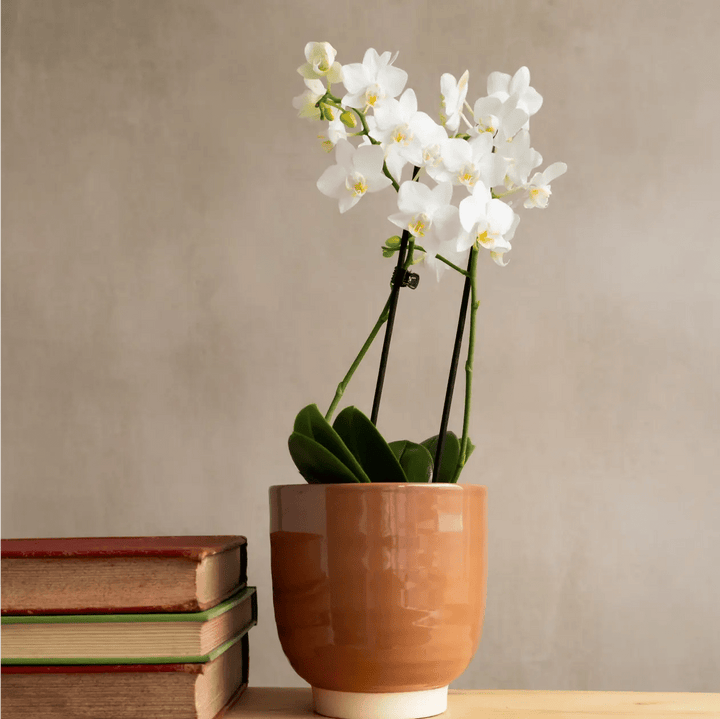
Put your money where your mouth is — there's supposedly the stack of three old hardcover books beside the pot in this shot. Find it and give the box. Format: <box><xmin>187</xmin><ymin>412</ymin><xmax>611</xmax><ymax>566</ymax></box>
<box><xmin>0</xmin><ymin>536</ymin><xmax>257</xmax><ymax>719</ymax></box>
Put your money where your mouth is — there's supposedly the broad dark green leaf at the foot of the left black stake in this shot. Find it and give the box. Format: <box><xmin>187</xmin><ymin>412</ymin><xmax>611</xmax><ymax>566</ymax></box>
<box><xmin>333</xmin><ymin>407</ymin><xmax>407</xmax><ymax>482</ymax></box>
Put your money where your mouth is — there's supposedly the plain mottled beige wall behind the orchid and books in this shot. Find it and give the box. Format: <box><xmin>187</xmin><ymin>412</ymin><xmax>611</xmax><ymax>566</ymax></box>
<box><xmin>0</xmin><ymin>0</ymin><xmax>720</xmax><ymax>691</ymax></box>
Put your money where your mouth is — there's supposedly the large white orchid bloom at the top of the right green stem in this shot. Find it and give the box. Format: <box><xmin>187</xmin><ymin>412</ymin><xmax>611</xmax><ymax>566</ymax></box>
<box><xmin>457</xmin><ymin>182</ymin><xmax>515</xmax><ymax>252</ymax></box>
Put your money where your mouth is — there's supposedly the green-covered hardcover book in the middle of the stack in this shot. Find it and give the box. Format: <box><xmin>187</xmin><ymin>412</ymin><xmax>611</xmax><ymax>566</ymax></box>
<box><xmin>0</xmin><ymin>587</ymin><xmax>257</xmax><ymax>669</ymax></box>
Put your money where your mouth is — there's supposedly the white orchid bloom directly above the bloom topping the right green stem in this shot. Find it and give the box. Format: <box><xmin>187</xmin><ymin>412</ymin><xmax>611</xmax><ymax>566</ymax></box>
<box><xmin>433</xmin><ymin>134</ymin><xmax>507</xmax><ymax>192</ymax></box>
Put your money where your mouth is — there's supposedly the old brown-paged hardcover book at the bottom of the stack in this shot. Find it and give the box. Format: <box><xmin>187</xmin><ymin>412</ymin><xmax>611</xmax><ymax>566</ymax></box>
<box><xmin>0</xmin><ymin>633</ymin><xmax>249</xmax><ymax>719</ymax></box>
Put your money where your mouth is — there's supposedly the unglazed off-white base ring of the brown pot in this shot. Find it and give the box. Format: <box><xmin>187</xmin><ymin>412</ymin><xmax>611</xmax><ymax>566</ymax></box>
<box><xmin>312</xmin><ymin>687</ymin><xmax>448</xmax><ymax>719</ymax></box>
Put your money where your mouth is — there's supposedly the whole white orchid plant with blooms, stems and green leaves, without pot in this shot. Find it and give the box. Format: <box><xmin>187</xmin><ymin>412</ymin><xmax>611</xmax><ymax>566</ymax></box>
<box><xmin>289</xmin><ymin>42</ymin><xmax>567</xmax><ymax>483</ymax></box>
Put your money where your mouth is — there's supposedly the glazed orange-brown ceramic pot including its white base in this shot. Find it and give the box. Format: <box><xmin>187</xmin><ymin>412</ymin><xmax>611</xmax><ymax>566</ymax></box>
<box><xmin>270</xmin><ymin>482</ymin><xmax>487</xmax><ymax>719</ymax></box>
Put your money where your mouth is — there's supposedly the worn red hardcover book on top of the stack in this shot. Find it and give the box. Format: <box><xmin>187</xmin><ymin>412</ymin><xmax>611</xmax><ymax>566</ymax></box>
<box><xmin>0</xmin><ymin>535</ymin><xmax>247</xmax><ymax>615</ymax></box>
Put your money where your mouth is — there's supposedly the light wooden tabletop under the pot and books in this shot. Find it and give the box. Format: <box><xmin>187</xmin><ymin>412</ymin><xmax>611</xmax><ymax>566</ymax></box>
<box><xmin>229</xmin><ymin>687</ymin><xmax>720</xmax><ymax>719</ymax></box>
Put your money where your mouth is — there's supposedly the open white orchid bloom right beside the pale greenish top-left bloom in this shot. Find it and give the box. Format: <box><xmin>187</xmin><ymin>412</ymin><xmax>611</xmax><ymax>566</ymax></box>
<box><xmin>342</xmin><ymin>48</ymin><xmax>407</xmax><ymax>110</ymax></box>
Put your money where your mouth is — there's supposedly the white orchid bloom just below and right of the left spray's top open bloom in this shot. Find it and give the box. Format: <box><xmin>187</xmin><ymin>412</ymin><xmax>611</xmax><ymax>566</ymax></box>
<box><xmin>370</xmin><ymin>89</ymin><xmax>432</xmax><ymax>182</ymax></box>
